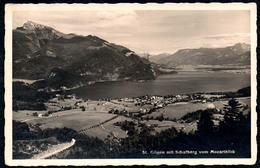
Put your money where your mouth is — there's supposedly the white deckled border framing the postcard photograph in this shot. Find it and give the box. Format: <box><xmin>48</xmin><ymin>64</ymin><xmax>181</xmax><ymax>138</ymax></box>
<box><xmin>5</xmin><ymin>3</ymin><xmax>257</xmax><ymax>166</ymax></box>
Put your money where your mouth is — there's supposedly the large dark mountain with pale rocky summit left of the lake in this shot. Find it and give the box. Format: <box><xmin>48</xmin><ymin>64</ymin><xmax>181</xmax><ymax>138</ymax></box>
<box><xmin>13</xmin><ymin>22</ymin><xmax>155</xmax><ymax>89</ymax></box>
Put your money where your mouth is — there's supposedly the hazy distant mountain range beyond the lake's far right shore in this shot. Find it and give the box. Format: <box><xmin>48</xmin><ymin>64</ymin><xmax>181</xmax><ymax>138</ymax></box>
<box><xmin>155</xmin><ymin>43</ymin><xmax>250</xmax><ymax>67</ymax></box>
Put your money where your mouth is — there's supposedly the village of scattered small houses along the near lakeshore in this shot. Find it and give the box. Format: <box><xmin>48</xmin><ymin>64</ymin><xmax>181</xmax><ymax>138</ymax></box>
<box><xmin>24</xmin><ymin>93</ymin><xmax>220</xmax><ymax>118</ymax></box>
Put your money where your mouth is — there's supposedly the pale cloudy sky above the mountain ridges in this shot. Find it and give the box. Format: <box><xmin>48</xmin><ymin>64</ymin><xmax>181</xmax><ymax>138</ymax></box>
<box><xmin>13</xmin><ymin>10</ymin><xmax>250</xmax><ymax>54</ymax></box>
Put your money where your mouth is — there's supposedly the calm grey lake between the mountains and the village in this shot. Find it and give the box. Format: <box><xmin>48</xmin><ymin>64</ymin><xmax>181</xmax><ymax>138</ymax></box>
<box><xmin>70</xmin><ymin>72</ymin><xmax>250</xmax><ymax>99</ymax></box>
